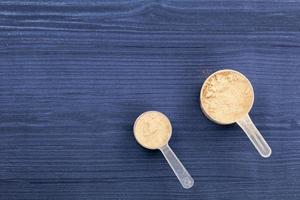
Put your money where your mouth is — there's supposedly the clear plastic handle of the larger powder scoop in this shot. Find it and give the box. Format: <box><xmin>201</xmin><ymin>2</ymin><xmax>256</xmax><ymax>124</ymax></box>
<box><xmin>237</xmin><ymin>114</ymin><xmax>272</xmax><ymax>158</ymax></box>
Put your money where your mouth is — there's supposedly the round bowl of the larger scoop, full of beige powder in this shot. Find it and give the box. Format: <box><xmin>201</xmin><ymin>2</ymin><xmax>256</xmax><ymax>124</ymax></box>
<box><xmin>200</xmin><ymin>70</ymin><xmax>254</xmax><ymax>124</ymax></box>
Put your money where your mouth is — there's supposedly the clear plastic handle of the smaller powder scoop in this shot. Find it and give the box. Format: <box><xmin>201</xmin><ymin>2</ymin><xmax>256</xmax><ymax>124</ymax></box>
<box><xmin>160</xmin><ymin>144</ymin><xmax>194</xmax><ymax>189</ymax></box>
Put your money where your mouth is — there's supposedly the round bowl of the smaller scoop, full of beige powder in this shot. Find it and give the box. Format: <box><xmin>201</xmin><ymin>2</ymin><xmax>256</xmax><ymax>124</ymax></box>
<box><xmin>133</xmin><ymin>111</ymin><xmax>172</xmax><ymax>149</ymax></box>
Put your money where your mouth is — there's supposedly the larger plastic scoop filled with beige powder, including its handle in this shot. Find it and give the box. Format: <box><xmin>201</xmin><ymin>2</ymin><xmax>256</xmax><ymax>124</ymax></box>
<box><xmin>200</xmin><ymin>69</ymin><xmax>272</xmax><ymax>158</ymax></box>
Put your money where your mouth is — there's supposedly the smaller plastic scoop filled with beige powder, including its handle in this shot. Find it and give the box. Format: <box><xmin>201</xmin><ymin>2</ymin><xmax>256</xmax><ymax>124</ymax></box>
<box><xmin>133</xmin><ymin>111</ymin><xmax>194</xmax><ymax>189</ymax></box>
